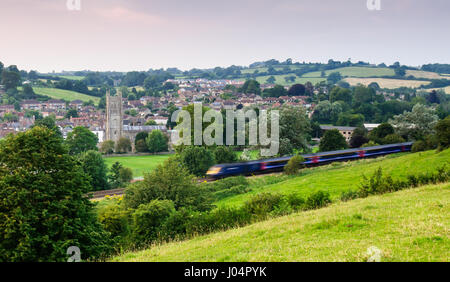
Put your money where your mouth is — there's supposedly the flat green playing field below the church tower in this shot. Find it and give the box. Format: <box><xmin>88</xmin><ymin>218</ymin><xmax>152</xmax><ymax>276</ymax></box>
<box><xmin>104</xmin><ymin>155</ymin><xmax>171</xmax><ymax>177</ymax></box>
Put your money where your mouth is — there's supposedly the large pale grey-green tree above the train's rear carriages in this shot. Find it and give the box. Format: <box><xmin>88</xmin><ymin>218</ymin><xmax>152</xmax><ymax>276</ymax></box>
<box><xmin>389</xmin><ymin>104</ymin><xmax>439</xmax><ymax>140</ymax></box>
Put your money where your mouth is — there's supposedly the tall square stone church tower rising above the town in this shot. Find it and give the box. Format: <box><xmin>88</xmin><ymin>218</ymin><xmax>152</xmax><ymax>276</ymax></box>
<box><xmin>105</xmin><ymin>91</ymin><xmax>123</xmax><ymax>142</ymax></box>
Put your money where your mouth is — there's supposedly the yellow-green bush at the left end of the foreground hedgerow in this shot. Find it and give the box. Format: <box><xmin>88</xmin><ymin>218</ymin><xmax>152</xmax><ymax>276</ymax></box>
<box><xmin>132</xmin><ymin>200</ymin><xmax>175</xmax><ymax>245</ymax></box>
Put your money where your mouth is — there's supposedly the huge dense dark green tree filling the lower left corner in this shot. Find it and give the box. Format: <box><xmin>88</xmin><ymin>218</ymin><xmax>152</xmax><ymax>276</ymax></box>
<box><xmin>0</xmin><ymin>127</ymin><xmax>111</xmax><ymax>262</ymax></box>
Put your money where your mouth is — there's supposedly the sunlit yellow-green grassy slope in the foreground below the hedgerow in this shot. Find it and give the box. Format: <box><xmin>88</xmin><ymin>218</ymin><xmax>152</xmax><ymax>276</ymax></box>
<box><xmin>112</xmin><ymin>183</ymin><xmax>450</xmax><ymax>262</ymax></box>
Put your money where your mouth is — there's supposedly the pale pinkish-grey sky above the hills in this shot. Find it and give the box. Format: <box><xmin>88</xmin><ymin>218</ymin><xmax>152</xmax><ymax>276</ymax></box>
<box><xmin>0</xmin><ymin>0</ymin><xmax>450</xmax><ymax>72</ymax></box>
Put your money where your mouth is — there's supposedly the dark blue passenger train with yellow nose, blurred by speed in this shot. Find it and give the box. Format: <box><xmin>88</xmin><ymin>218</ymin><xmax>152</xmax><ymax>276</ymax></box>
<box><xmin>206</xmin><ymin>142</ymin><xmax>413</xmax><ymax>180</ymax></box>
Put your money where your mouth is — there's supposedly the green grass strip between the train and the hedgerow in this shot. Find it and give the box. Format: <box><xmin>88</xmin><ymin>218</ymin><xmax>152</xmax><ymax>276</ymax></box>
<box><xmin>215</xmin><ymin>149</ymin><xmax>450</xmax><ymax>206</ymax></box>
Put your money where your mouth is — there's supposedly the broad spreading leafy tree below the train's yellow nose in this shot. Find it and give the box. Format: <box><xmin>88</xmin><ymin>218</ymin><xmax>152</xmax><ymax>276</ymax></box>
<box><xmin>123</xmin><ymin>158</ymin><xmax>212</xmax><ymax>211</ymax></box>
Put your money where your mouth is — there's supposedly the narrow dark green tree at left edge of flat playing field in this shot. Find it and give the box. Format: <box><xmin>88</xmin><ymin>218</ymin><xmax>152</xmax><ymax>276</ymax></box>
<box><xmin>78</xmin><ymin>151</ymin><xmax>109</xmax><ymax>191</ymax></box>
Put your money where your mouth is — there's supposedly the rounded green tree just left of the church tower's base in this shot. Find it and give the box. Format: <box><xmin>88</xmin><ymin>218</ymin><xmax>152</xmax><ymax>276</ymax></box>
<box><xmin>66</xmin><ymin>126</ymin><xmax>98</xmax><ymax>155</ymax></box>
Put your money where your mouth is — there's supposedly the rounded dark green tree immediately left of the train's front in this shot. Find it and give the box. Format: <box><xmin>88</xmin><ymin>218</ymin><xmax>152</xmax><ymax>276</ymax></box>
<box><xmin>179</xmin><ymin>146</ymin><xmax>215</xmax><ymax>176</ymax></box>
